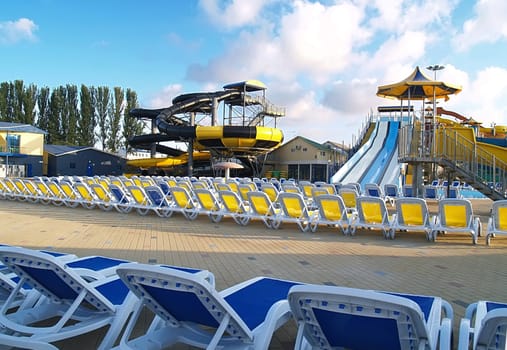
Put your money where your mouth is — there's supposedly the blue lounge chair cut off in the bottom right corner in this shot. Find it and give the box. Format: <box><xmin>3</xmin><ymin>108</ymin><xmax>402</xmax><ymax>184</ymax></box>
<box><xmin>458</xmin><ymin>300</ymin><xmax>507</xmax><ymax>350</ymax></box>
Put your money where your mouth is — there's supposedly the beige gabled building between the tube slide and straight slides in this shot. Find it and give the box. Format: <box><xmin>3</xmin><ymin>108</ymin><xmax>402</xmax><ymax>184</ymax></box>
<box><xmin>264</xmin><ymin>136</ymin><xmax>348</xmax><ymax>182</ymax></box>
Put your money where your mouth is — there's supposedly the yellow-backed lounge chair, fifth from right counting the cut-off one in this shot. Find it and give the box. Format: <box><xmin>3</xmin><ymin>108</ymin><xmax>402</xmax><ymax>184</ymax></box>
<box><xmin>310</xmin><ymin>194</ymin><xmax>352</xmax><ymax>234</ymax></box>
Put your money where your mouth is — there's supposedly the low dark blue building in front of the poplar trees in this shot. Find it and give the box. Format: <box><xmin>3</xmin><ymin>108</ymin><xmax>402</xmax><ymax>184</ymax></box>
<box><xmin>44</xmin><ymin>145</ymin><xmax>126</xmax><ymax>176</ymax></box>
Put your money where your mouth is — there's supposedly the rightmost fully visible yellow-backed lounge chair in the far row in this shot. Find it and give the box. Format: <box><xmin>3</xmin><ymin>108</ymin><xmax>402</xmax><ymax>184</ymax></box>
<box><xmin>430</xmin><ymin>198</ymin><xmax>482</xmax><ymax>244</ymax></box>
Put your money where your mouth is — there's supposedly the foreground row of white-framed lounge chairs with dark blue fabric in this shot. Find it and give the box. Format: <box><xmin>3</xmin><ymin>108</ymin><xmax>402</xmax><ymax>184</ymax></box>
<box><xmin>0</xmin><ymin>246</ymin><xmax>507</xmax><ymax>350</ymax></box>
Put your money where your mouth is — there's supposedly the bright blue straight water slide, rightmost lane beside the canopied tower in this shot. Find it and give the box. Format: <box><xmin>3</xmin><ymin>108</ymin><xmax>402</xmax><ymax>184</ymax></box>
<box><xmin>359</xmin><ymin>122</ymin><xmax>400</xmax><ymax>187</ymax></box>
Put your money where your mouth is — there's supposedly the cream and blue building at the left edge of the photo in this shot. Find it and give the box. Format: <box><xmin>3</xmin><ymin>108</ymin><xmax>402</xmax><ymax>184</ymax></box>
<box><xmin>0</xmin><ymin>122</ymin><xmax>46</xmax><ymax>177</ymax></box>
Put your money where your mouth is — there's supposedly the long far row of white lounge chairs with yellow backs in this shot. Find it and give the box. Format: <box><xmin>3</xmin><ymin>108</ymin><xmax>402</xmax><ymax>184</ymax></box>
<box><xmin>0</xmin><ymin>179</ymin><xmax>507</xmax><ymax>245</ymax></box>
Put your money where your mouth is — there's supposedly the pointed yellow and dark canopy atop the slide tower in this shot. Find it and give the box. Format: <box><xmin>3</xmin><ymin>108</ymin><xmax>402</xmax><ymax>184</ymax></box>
<box><xmin>377</xmin><ymin>67</ymin><xmax>461</xmax><ymax>101</ymax></box>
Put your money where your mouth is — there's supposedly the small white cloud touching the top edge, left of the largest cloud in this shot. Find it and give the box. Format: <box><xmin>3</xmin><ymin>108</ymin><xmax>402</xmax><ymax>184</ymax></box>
<box><xmin>199</xmin><ymin>0</ymin><xmax>267</xmax><ymax>29</ymax></box>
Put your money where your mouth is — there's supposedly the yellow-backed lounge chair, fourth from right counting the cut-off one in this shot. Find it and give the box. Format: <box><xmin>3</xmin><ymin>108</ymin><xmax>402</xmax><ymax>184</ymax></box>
<box><xmin>348</xmin><ymin>196</ymin><xmax>392</xmax><ymax>238</ymax></box>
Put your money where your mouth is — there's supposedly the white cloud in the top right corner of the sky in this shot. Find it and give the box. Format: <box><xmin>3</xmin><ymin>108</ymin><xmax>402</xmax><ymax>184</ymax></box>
<box><xmin>454</xmin><ymin>0</ymin><xmax>507</xmax><ymax>51</ymax></box>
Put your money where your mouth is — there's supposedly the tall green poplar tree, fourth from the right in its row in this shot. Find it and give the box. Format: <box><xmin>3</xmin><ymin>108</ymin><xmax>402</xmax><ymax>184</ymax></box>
<box><xmin>77</xmin><ymin>85</ymin><xmax>95</xmax><ymax>146</ymax></box>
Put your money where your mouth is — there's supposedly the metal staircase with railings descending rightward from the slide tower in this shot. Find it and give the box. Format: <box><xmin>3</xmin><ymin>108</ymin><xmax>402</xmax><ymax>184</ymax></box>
<box><xmin>398</xmin><ymin>124</ymin><xmax>507</xmax><ymax>200</ymax></box>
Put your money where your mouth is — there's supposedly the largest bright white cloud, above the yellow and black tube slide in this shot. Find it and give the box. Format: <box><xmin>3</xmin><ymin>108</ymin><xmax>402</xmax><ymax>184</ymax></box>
<box><xmin>188</xmin><ymin>1</ymin><xmax>371</xmax><ymax>84</ymax></box>
